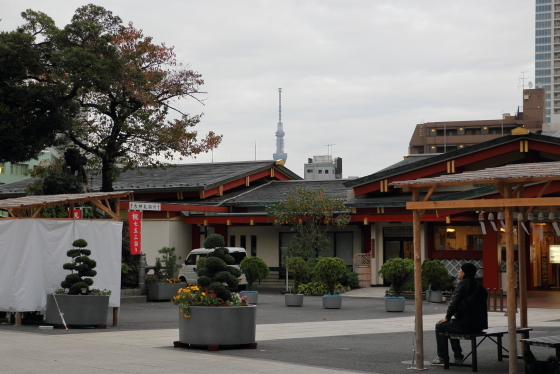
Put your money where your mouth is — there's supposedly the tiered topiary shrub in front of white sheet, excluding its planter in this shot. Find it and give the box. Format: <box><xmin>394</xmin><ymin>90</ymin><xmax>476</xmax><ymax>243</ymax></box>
<box><xmin>60</xmin><ymin>239</ymin><xmax>97</xmax><ymax>295</ymax></box>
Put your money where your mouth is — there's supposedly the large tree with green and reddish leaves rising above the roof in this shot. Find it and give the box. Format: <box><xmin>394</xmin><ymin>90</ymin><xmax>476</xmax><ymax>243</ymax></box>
<box><xmin>0</xmin><ymin>4</ymin><xmax>221</xmax><ymax>192</ymax></box>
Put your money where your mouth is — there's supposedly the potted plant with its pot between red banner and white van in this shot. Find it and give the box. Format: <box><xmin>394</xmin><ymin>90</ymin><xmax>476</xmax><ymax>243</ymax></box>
<box><xmin>146</xmin><ymin>247</ymin><xmax>183</xmax><ymax>300</ymax></box>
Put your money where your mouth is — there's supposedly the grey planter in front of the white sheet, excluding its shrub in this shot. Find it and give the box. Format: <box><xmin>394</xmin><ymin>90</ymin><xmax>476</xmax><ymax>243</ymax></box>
<box><xmin>45</xmin><ymin>294</ymin><xmax>109</xmax><ymax>326</ymax></box>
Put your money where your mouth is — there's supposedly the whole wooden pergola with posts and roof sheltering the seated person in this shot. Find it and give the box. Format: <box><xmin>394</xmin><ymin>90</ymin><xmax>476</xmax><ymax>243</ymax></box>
<box><xmin>391</xmin><ymin>162</ymin><xmax>560</xmax><ymax>374</ymax></box>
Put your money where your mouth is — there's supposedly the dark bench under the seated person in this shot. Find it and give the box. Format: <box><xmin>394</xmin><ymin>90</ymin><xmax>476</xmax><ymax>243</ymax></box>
<box><xmin>440</xmin><ymin>326</ymin><xmax>532</xmax><ymax>372</ymax></box>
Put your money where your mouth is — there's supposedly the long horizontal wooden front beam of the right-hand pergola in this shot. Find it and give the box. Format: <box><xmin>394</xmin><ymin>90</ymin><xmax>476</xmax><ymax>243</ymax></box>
<box><xmin>406</xmin><ymin>197</ymin><xmax>560</xmax><ymax>210</ymax></box>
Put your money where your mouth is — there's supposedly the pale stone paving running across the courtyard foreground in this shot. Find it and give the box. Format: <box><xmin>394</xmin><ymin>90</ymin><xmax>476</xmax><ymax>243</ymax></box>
<box><xmin>0</xmin><ymin>288</ymin><xmax>560</xmax><ymax>374</ymax></box>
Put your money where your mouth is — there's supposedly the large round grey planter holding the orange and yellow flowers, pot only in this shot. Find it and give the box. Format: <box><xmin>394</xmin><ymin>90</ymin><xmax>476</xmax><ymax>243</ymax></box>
<box><xmin>179</xmin><ymin>305</ymin><xmax>257</xmax><ymax>345</ymax></box>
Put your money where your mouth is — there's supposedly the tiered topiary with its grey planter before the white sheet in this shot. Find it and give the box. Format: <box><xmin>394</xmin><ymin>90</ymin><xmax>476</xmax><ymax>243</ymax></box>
<box><xmin>45</xmin><ymin>239</ymin><xmax>111</xmax><ymax>327</ymax></box>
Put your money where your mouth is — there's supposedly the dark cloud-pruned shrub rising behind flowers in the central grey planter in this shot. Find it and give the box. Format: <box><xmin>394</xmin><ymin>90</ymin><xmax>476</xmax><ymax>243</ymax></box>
<box><xmin>196</xmin><ymin>244</ymin><xmax>241</xmax><ymax>301</ymax></box>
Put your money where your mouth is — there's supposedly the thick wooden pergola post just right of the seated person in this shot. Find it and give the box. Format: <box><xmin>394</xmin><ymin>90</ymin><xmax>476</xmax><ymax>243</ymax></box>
<box><xmin>504</xmin><ymin>200</ymin><xmax>517</xmax><ymax>374</ymax></box>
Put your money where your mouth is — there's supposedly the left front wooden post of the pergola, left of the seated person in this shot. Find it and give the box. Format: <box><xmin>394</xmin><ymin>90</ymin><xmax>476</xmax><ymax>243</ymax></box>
<box><xmin>412</xmin><ymin>190</ymin><xmax>424</xmax><ymax>370</ymax></box>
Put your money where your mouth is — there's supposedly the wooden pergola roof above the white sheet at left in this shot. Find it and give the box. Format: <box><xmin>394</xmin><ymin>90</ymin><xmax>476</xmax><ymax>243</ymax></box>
<box><xmin>0</xmin><ymin>191</ymin><xmax>129</xmax><ymax>220</ymax></box>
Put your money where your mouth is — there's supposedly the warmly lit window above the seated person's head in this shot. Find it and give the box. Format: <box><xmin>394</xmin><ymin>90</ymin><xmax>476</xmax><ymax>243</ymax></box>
<box><xmin>434</xmin><ymin>226</ymin><xmax>483</xmax><ymax>251</ymax></box>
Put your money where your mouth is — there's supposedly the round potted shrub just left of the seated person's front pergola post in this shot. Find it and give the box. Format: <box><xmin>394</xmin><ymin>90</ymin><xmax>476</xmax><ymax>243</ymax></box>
<box><xmin>378</xmin><ymin>258</ymin><xmax>414</xmax><ymax>312</ymax></box>
